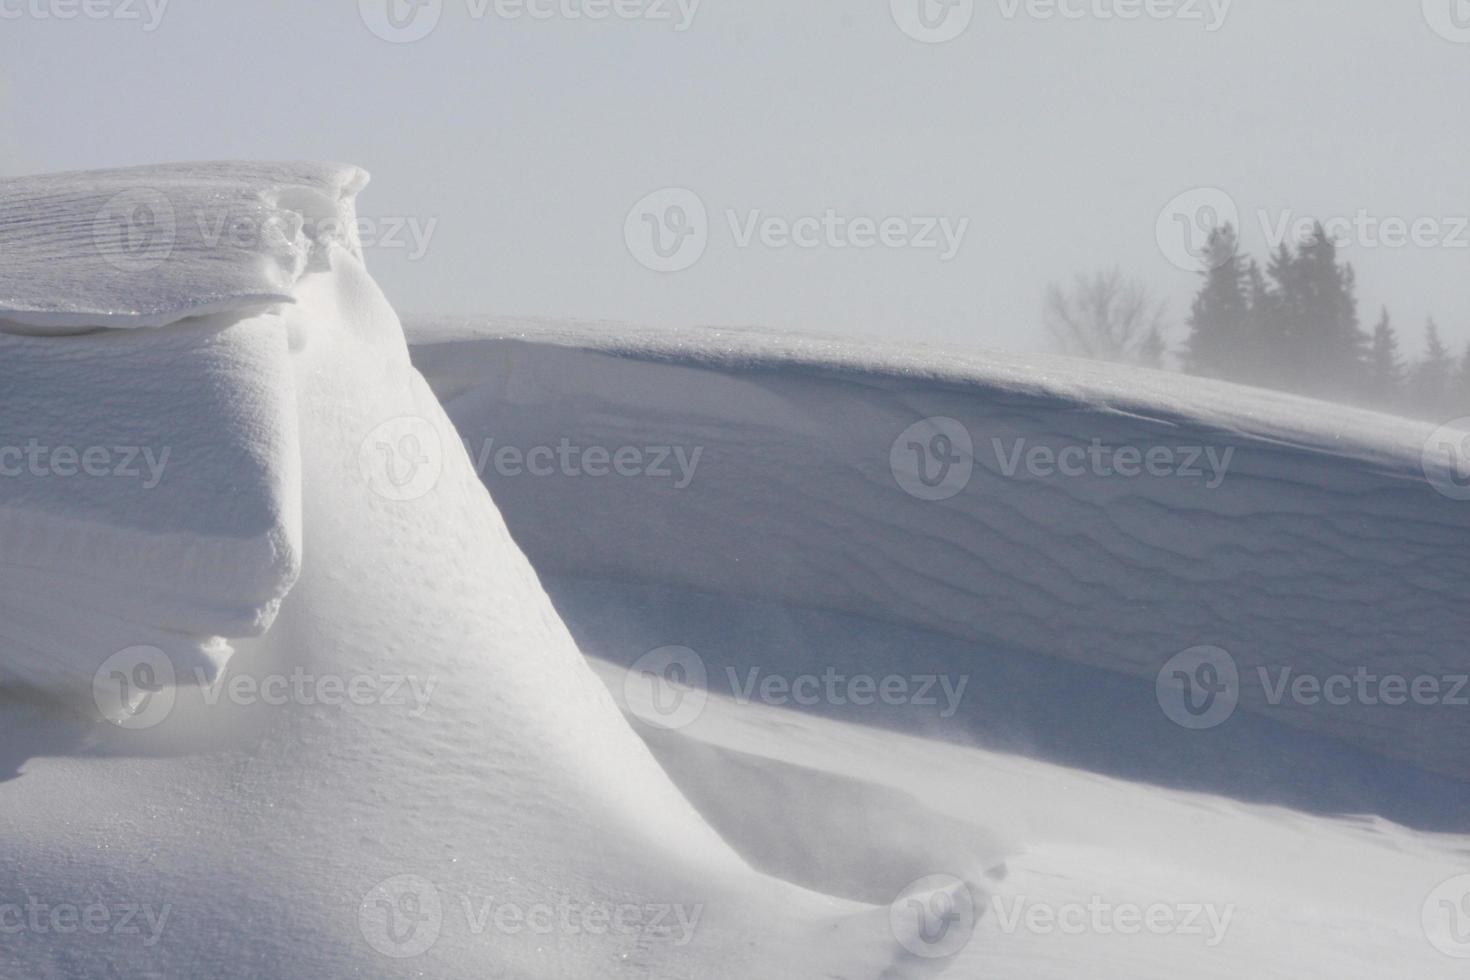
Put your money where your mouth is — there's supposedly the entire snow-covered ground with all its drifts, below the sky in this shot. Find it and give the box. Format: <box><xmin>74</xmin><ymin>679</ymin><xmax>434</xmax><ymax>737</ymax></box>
<box><xmin>0</xmin><ymin>165</ymin><xmax>1470</xmax><ymax>980</ymax></box>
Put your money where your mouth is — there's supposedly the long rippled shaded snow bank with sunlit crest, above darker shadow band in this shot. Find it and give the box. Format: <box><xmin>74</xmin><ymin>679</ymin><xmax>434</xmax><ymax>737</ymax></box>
<box><xmin>410</xmin><ymin>319</ymin><xmax>1470</xmax><ymax>777</ymax></box>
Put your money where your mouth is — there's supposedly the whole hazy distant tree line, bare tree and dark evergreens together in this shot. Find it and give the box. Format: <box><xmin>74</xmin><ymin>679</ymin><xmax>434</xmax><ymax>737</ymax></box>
<box><xmin>1042</xmin><ymin>225</ymin><xmax>1470</xmax><ymax>422</ymax></box>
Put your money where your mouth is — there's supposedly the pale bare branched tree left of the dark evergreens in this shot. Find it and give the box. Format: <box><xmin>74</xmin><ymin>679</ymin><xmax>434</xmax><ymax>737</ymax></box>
<box><xmin>1042</xmin><ymin>269</ymin><xmax>1164</xmax><ymax>367</ymax></box>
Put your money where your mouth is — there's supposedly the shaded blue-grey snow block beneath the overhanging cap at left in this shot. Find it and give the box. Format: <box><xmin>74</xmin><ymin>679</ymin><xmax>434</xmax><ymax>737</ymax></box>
<box><xmin>0</xmin><ymin>319</ymin><xmax>301</xmax><ymax>708</ymax></box>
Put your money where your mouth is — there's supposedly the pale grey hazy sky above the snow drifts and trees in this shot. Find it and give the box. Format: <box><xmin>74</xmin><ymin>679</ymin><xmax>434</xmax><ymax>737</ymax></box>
<box><xmin>0</xmin><ymin>0</ymin><xmax>1470</xmax><ymax>351</ymax></box>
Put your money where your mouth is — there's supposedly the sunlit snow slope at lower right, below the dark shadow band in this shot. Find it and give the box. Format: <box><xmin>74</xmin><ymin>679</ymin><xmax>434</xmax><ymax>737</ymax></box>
<box><xmin>598</xmin><ymin>637</ymin><xmax>1470</xmax><ymax>980</ymax></box>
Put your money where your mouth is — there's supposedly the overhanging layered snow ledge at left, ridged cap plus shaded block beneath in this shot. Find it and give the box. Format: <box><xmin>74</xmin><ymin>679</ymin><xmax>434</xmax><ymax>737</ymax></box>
<box><xmin>0</xmin><ymin>165</ymin><xmax>338</xmax><ymax>710</ymax></box>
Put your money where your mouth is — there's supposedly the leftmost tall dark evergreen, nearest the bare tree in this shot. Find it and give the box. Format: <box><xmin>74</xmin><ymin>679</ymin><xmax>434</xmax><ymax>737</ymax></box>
<box><xmin>1185</xmin><ymin>225</ymin><xmax>1252</xmax><ymax>381</ymax></box>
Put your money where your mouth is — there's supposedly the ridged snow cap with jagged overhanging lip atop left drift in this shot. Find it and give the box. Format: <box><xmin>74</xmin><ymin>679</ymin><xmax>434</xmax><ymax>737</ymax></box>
<box><xmin>0</xmin><ymin>163</ymin><xmax>368</xmax><ymax>334</ymax></box>
